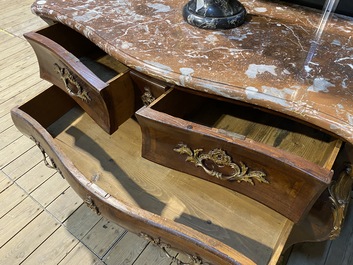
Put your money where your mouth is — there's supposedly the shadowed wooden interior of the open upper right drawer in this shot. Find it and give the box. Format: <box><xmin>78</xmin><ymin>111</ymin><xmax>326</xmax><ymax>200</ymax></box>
<box><xmin>150</xmin><ymin>89</ymin><xmax>342</xmax><ymax>169</ymax></box>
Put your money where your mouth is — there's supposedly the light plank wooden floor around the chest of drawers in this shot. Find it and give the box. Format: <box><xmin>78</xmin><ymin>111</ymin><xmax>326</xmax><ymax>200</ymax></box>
<box><xmin>0</xmin><ymin>0</ymin><xmax>353</xmax><ymax>265</ymax></box>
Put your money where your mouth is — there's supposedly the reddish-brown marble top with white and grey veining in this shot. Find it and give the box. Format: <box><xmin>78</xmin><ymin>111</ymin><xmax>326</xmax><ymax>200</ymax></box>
<box><xmin>32</xmin><ymin>0</ymin><xmax>353</xmax><ymax>143</ymax></box>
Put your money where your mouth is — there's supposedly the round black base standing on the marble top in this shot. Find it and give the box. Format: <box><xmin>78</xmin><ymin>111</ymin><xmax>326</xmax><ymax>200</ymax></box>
<box><xmin>183</xmin><ymin>0</ymin><xmax>246</xmax><ymax>29</ymax></box>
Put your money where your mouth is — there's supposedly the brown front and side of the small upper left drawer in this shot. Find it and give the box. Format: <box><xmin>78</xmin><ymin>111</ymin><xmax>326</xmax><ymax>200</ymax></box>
<box><xmin>25</xmin><ymin>24</ymin><xmax>134</xmax><ymax>133</ymax></box>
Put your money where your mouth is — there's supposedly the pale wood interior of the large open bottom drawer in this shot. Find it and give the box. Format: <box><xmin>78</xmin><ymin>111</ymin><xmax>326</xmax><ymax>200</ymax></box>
<box><xmin>14</xmin><ymin>86</ymin><xmax>288</xmax><ymax>264</ymax></box>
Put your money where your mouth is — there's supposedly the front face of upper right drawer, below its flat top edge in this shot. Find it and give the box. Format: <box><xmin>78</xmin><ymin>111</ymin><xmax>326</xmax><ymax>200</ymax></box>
<box><xmin>137</xmin><ymin>112</ymin><xmax>331</xmax><ymax>222</ymax></box>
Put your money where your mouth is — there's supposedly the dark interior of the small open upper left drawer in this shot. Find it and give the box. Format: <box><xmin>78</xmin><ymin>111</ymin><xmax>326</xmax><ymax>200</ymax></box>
<box><xmin>37</xmin><ymin>23</ymin><xmax>129</xmax><ymax>82</ymax></box>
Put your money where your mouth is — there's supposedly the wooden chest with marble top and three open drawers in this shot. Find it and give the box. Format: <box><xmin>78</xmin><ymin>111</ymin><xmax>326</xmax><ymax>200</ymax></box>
<box><xmin>12</xmin><ymin>0</ymin><xmax>353</xmax><ymax>264</ymax></box>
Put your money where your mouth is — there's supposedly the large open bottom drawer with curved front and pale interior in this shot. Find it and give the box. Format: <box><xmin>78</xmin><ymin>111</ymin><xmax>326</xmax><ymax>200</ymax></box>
<box><xmin>12</xmin><ymin>86</ymin><xmax>293</xmax><ymax>265</ymax></box>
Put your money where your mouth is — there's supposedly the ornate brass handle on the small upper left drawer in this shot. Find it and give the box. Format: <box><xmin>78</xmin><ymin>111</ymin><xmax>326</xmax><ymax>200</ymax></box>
<box><xmin>54</xmin><ymin>63</ymin><xmax>91</xmax><ymax>102</ymax></box>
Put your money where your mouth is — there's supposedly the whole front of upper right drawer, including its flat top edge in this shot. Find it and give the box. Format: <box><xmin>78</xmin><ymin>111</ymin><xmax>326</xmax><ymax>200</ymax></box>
<box><xmin>136</xmin><ymin>89</ymin><xmax>333</xmax><ymax>222</ymax></box>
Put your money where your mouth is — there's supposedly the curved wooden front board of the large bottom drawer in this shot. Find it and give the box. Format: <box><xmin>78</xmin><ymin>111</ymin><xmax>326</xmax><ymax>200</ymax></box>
<box><xmin>11</xmin><ymin>104</ymin><xmax>255</xmax><ymax>265</ymax></box>
